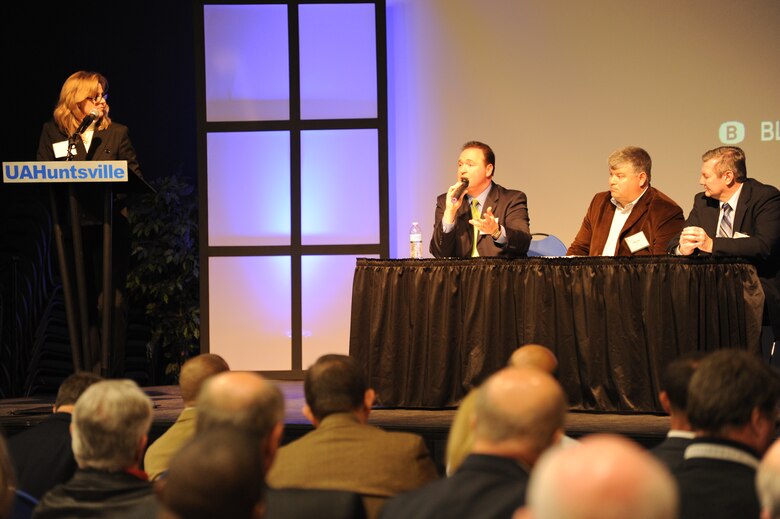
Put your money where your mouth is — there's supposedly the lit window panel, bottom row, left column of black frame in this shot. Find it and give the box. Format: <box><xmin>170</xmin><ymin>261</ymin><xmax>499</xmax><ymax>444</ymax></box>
<box><xmin>209</xmin><ymin>256</ymin><xmax>292</xmax><ymax>371</ymax></box>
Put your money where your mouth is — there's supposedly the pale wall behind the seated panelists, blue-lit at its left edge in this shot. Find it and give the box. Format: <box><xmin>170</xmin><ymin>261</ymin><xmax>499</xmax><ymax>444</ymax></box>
<box><xmin>387</xmin><ymin>0</ymin><xmax>780</xmax><ymax>256</ymax></box>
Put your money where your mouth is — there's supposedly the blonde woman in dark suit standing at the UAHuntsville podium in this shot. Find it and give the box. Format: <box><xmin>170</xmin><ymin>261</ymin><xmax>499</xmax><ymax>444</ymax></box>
<box><xmin>37</xmin><ymin>71</ymin><xmax>143</xmax><ymax>376</ymax></box>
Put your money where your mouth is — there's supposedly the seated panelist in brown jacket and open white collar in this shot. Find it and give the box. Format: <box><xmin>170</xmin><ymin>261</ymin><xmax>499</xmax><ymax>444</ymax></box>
<box><xmin>566</xmin><ymin>146</ymin><xmax>684</xmax><ymax>256</ymax></box>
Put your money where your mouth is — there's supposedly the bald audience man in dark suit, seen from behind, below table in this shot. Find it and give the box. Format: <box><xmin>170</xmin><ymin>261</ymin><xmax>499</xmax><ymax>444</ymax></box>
<box><xmin>381</xmin><ymin>368</ymin><xmax>566</xmax><ymax>519</ymax></box>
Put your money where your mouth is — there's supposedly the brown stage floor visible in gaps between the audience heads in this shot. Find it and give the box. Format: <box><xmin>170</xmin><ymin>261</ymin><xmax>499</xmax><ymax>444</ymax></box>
<box><xmin>0</xmin><ymin>380</ymin><xmax>669</xmax><ymax>470</ymax></box>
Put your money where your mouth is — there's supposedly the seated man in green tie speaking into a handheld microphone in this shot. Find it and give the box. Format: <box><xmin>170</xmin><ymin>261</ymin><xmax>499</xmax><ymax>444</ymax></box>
<box><xmin>430</xmin><ymin>141</ymin><xmax>531</xmax><ymax>258</ymax></box>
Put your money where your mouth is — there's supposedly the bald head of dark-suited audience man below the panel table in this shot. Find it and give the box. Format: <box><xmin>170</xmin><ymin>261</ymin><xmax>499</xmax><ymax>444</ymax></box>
<box><xmin>472</xmin><ymin>368</ymin><xmax>566</xmax><ymax>465</ymax></box>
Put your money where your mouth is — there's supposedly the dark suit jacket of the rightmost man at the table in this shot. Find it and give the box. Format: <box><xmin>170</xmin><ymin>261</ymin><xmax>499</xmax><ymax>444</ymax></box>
<box><xmin>668</xmin><ymin>178</ymin><xmax>780</xmax><ymax>337</ymax></box>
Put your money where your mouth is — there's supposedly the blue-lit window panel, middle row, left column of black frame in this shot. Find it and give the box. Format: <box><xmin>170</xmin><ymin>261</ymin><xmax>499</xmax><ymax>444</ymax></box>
<box><xmin>207</xmin><ymin>132</ymin><xmax>290</xmax><ymax>246</ymax></box>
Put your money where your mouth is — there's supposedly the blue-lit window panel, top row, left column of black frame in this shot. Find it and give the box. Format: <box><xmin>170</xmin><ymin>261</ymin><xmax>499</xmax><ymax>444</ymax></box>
<box><xmin>203</xmin><ymin>5</ymin><xmax>290</xmax><ymax>121</ymax></box>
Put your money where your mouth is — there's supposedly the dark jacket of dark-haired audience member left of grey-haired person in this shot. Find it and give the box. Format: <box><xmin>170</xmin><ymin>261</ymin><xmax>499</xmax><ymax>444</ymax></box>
<box><xmin>8</xmin><ymin>413</ymin><xmax>76</xmax><ymax>499</ymax></box>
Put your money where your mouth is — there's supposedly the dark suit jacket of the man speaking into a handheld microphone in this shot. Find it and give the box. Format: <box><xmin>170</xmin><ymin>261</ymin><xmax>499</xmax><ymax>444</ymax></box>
<box><xmin>430</xmin><ymin>182</ymin><xmax>531</xmax><ymax>258</ymax></box>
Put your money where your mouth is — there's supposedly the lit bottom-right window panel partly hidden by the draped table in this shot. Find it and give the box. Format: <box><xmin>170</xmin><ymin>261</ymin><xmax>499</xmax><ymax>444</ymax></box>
<box><xmin>301</xmin><ymin>255</ymin><xmax>379</xmax><ymax>369</ymax></box>
